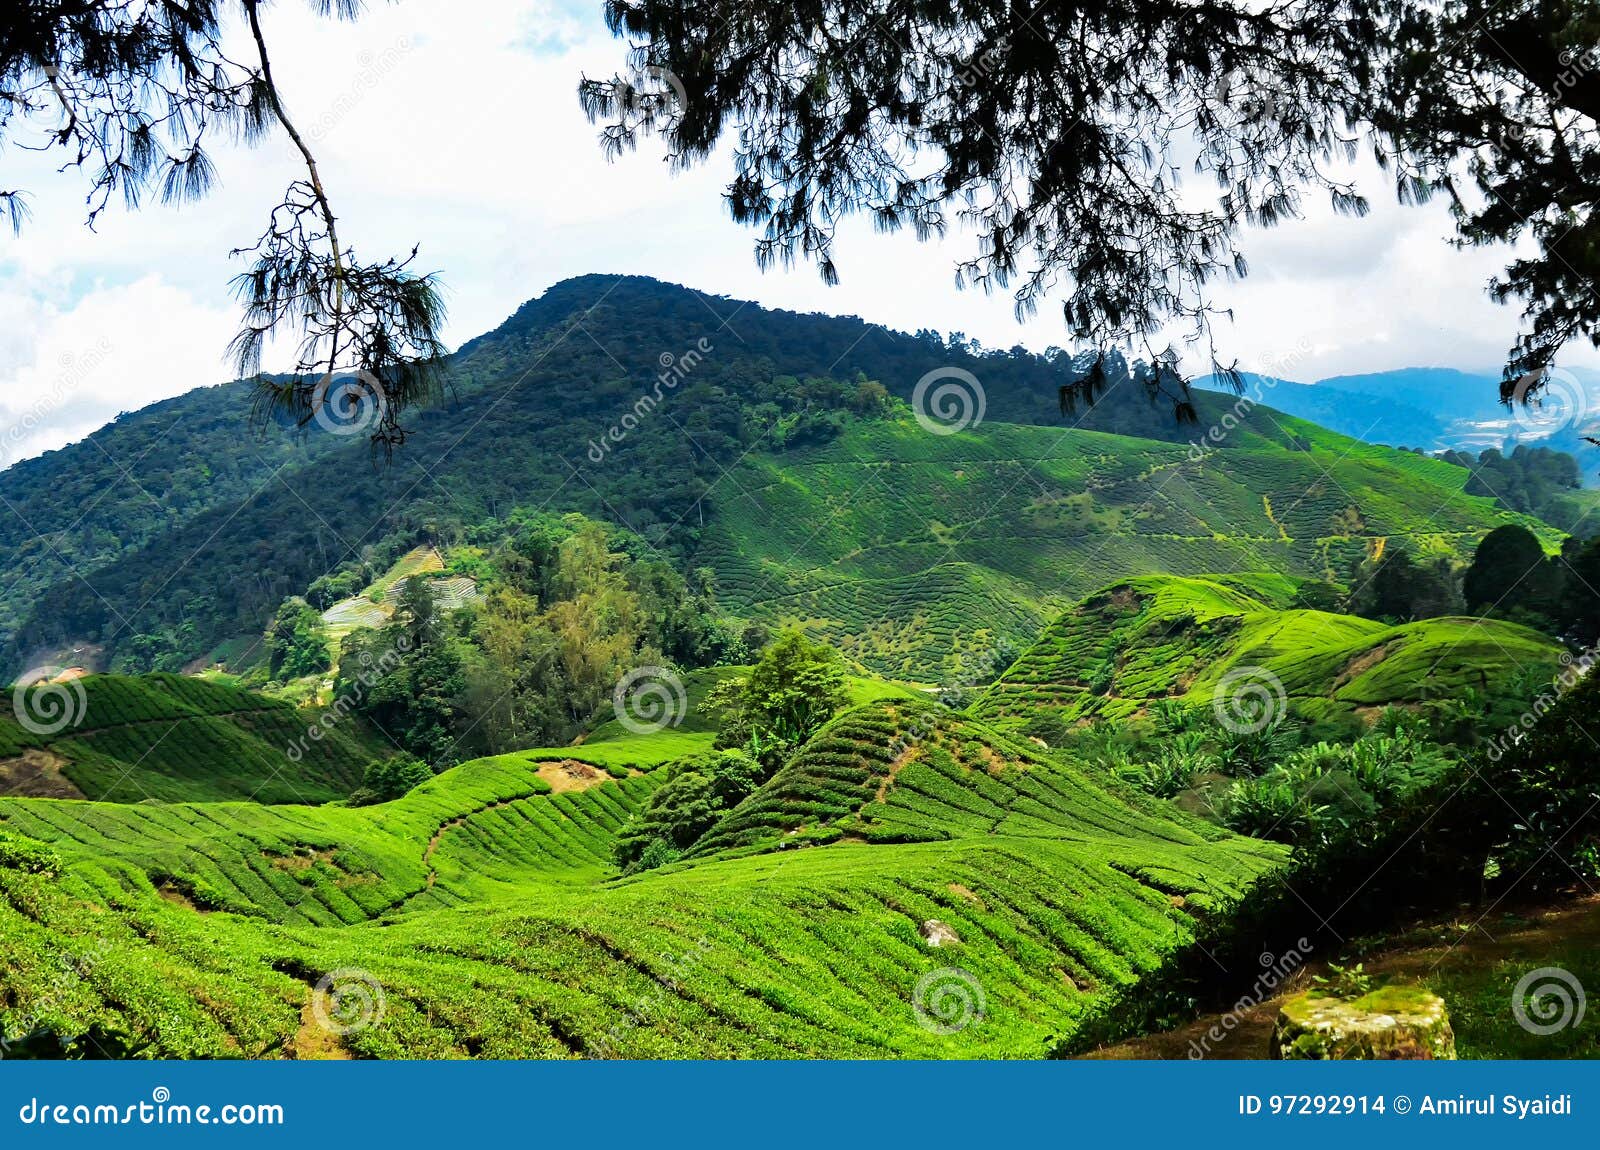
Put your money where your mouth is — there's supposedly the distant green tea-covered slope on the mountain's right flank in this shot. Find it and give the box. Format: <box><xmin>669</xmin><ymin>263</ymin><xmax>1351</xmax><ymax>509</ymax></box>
<box><xmin>696</xmin><ymin>419</ymin><xmax>1558</xmax><ymax>680</ymax></box>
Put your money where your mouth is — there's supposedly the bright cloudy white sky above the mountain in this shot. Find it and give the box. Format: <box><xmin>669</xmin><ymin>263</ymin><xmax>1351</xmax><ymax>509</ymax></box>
<box><xmin>0</xmin><ymin>0</ymin><xmax>1600</xmax><ymax>465</ymax></box>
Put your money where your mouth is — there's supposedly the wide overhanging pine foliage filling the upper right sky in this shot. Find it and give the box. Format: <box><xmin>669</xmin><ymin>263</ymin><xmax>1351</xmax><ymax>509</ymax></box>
<box><xmin>579</xmin><ymin>0</ymin><xmax>1600</xmax><ymax>417</ymax></box>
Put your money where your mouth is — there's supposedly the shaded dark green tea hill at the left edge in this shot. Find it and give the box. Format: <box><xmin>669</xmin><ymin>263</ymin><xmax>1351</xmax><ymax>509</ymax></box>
<box><xmin>0</xmin><ymin>675</ymin><xmax>384</xmax><ymax>803</ymax></box>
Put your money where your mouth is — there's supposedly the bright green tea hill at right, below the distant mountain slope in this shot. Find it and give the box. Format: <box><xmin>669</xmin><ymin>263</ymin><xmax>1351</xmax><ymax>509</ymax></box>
<box><xmin>973</xmin><ymin>576</ymin><xmax>1563</xmax><ymax>726</ymax></box>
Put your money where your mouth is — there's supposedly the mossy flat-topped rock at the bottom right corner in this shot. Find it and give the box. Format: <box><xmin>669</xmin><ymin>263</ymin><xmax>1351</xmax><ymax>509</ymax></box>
<box><xmin>1269</xmin><ymin>987</ymin><xmax>1456</xmax><ymax>1059</ymax></box>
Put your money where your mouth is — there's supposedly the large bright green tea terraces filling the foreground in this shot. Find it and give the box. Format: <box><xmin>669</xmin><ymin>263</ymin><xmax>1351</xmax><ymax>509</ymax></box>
<box><xmin>0</xmin><ymin>699</ymin><xmax>1283</xmax><ymax>1057</ymax></box>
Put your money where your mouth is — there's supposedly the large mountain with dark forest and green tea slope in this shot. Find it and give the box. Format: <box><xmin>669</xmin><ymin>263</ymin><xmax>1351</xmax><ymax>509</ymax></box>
<box><xmin>0</xmin><ymin>277</ymin><xmax>1574</xmax><ymax>678</ymax></box>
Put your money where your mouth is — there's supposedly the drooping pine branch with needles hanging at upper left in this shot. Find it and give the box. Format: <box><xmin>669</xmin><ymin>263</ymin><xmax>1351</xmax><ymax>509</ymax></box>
<box><xmin>0</xmin><ymin>0</ymin><xmax>445</xmax><ymax>448</ymax></box>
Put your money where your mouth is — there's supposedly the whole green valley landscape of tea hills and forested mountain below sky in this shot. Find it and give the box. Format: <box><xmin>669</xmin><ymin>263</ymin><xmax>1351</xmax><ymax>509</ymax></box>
<box><xmin>0</xmin><ymin>277</ymin><xmax>1600</xmax><ymax>1059</ymax></box>
